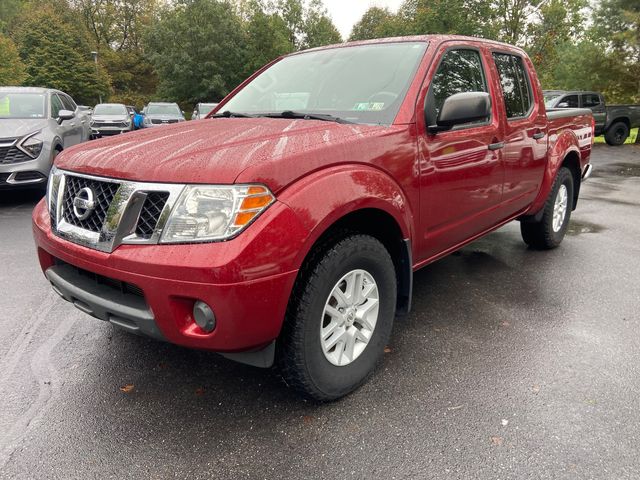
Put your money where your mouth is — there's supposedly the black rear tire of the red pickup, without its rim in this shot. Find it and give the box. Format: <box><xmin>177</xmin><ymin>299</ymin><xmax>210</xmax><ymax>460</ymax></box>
<box><xmin>520</xmin><ymin>167</ymin><xmax>574</xmax><ymax>250</ymax></box>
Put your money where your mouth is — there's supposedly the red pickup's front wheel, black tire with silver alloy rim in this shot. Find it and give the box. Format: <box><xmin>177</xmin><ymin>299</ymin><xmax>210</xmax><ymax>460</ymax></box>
<box><xmin>277</xmin><ymin>235</ymin><xmax>396</xmax><ymax>401</ymax></box>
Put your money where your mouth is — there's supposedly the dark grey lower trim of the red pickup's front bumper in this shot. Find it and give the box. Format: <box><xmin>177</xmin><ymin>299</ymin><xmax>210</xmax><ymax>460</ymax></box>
<box><xmin>45</xmin><ymin>264</ymin><xmax>164</xmax><ymax>340</ymax></box>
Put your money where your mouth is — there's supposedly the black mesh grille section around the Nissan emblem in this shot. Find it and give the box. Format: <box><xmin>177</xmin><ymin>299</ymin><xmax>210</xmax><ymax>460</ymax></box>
<box><xmin>62</xmin><ymin>176</ymin><xmax>119</xmax><ymax>233</ymax></box>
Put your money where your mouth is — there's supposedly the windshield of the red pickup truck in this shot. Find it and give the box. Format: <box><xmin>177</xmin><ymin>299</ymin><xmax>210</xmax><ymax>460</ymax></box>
<box><xmin>222</xmin><ymin>42</ymin><xmax>427</xmax><ymax>125</ymax></box>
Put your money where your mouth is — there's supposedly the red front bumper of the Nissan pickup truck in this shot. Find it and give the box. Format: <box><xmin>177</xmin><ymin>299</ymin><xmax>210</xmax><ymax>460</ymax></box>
<box><xmin>33</xmin><ymin>201</ymin><xmax>308</xmax><ymax>353</ymax></box>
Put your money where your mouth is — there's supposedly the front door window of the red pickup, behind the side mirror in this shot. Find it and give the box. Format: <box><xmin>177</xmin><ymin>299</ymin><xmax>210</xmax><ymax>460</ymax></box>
<box><xmin>427</xmin><ymin>49</ymin><xmax>488</xmax><ymax>125</ymax></box>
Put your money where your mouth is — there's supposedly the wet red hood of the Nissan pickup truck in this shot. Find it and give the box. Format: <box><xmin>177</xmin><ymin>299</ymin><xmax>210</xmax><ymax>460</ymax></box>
<box><xmin>56</xmin><ymin>118</ymin><xmax>397</xmax><ymax>192</ymax></box>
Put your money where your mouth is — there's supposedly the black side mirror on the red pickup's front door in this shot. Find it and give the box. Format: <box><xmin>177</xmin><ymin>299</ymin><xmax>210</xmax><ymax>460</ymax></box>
<box><xmin>428</xmin><ymin>92</ymin><xmax>491</xmax><ymax>133</ymax></box>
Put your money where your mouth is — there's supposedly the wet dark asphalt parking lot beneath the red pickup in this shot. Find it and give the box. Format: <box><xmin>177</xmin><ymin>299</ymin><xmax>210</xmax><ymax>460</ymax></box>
<box><xmin>0</xmin><ymin>145</ymin><xmax>640</xmax><ymax>479</ymax></box>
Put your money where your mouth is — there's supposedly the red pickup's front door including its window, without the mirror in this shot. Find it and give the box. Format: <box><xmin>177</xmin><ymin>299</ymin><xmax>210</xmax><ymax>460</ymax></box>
<box><xmin>418</xmin><ymin>44</ymin><xmax>504</xmax><ymax>257</ymax></box>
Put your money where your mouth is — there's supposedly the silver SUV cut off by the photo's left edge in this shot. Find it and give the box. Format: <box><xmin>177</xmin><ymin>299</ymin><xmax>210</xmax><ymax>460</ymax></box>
<box><xmin>0</xmin><ymin>87</ymin><xmax>91</xmax><ymax>189</ymax></box>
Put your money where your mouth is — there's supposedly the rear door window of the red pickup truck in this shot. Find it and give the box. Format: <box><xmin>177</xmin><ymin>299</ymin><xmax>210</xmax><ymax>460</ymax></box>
<box><xmin>493</xmin><ymin>53</ymin><xmax>533</xmax><ymax>118</ymax></box>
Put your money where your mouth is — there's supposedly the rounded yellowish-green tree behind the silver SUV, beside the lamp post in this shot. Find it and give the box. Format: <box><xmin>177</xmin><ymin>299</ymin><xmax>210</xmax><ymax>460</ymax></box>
<box><xmin>14</xmin><ymin>2</ymin><xmax>110</xmax><ymax>103</ymax></box>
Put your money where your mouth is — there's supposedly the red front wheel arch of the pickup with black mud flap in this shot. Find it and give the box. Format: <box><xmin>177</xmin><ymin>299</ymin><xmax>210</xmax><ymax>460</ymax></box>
<box><xmin>279</xmin><ymin>166</ymin><xmax>413</xmax><ymax>313</ymax></box>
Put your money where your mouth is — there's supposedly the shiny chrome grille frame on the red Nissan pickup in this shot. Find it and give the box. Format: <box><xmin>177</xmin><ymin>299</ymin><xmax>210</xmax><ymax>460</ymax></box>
<box><xmin>48</xmin><ymin>169</ymin><xmax>184</xmax><ymax>253</ymax></box>
